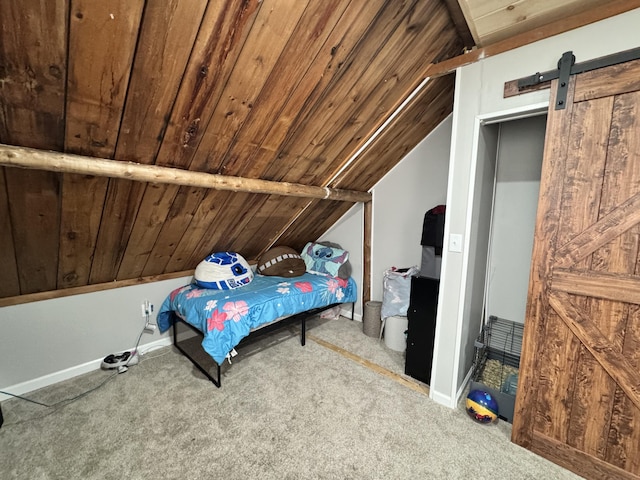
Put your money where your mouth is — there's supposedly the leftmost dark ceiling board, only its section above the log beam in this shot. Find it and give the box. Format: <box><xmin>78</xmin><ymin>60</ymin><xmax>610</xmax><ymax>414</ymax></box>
<box><xmin>0</xmin><ymin>0</ymin><xmax>68</xmax><ymax>149</ymax></box>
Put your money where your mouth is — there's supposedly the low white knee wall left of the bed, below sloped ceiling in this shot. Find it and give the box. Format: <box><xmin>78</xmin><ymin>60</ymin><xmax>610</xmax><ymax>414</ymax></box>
<box><xmin>0</xmin><ymin>277</ymin><xmax>191</xmax><ymax>400</ymax></box>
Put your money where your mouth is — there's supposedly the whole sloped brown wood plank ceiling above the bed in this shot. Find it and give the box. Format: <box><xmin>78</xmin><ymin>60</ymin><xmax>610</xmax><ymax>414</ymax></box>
<box><xmin>0</xmin><ymin>0</ymin><xmax>632</xmax><ymax>298</ymax></box>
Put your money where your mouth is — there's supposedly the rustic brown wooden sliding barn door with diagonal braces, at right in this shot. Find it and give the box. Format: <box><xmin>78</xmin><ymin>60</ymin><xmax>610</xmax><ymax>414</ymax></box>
<box><xmin>512</xmin><ymin>57</ymin><xmax>640</xmax><ymax>480</ymax></box>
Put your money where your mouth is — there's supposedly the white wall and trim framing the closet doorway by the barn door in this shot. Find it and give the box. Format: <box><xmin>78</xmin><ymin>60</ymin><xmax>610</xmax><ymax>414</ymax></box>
<box><xmin>430</xmin><ymin>9</ymin><xmax>640</xmax><ymax>408</ymax></box>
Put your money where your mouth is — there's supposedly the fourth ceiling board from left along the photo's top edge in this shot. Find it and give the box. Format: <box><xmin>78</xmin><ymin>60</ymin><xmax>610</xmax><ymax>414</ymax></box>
<box><xmin>118</xmin><ymin>0</ymin><xmax>262</xmax><ymax>278</ymax></box>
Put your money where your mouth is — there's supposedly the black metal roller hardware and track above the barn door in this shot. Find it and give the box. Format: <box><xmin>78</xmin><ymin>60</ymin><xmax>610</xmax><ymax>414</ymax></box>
<box><xmin>518</xmin><ymin>48</ymin><xmax>640</xmax><ymax>110</ymax></box>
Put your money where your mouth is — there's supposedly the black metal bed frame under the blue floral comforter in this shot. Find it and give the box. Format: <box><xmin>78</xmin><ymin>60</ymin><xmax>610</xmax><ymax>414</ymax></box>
<box><xmin>173</xmin><ymin>302</ymin><xmax>355</xmax><ymax>388</ymax></box>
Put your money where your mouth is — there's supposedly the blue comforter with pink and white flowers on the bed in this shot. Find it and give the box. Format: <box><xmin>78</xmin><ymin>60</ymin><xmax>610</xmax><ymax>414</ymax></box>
<box><xmin>157</xmin><ymin>273</ymin><xmax>357</xmax><ymax>365</ymax></box>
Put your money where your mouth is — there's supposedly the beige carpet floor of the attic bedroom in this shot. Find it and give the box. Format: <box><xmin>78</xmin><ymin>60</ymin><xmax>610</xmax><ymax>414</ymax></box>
<box><xmin>0</xmin><ymin>318</ymin><xmax>578</xmax><ymax>480</ymax></box>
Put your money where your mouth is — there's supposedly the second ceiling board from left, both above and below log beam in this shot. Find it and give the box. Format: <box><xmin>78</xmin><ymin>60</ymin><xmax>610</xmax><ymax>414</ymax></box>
<box><xmin>59</xmin><ymin>0</ymin><xmax>144</xmax><ymax>286</ymax></box>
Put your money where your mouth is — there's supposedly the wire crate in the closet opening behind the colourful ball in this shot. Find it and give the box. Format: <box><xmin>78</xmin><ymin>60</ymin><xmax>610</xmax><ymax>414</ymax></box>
<box><xmin>471</xmin><ymin>315</ymin><xmax>524</xmax><ymax>422</ymax></box>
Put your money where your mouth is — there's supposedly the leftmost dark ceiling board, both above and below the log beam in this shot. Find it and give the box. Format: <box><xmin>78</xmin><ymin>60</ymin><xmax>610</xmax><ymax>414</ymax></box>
<box><xmin>0</xmin><ymin>0</ymin><xmax>68</xmax><ymax>294</ymax></box>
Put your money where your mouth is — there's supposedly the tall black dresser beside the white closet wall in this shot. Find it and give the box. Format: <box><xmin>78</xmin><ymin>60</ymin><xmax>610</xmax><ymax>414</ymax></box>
<box><xmin>404</xmin><ymin>276</ymin><xmax>440</xmax><ymax>384</ymax></box>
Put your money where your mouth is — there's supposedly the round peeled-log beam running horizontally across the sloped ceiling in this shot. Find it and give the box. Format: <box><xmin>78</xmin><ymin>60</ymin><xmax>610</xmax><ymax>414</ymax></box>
<box><xmin>0</xmin><ymin>144</ymin><xmax>371</xmax><ymax>203</ymax></box>
